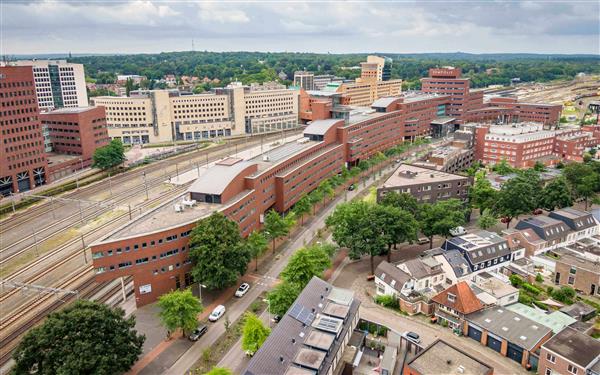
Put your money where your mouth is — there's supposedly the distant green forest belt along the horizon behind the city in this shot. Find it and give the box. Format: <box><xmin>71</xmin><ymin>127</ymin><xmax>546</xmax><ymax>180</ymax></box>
<box><xmin>70</xmin><ymin>51</ymin><xmax>600</xmax><ymax>89</ymax></box>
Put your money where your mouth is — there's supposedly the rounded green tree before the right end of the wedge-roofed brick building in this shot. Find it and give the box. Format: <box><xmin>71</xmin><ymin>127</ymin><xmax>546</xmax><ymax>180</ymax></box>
<box><xmin>420</xmin><ymin>199</ymin><xmax>466</xmax><ymax>249</ymax></box>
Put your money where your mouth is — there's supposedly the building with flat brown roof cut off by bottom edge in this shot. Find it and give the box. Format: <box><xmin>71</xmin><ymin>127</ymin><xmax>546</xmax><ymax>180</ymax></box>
<box><xmin>402</xmin><ymin>339</ymin><xmax>494</xmax><ymax>375</ymax></box>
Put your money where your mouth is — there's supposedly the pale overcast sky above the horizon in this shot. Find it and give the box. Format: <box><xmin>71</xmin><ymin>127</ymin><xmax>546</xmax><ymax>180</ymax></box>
<box><xmin>0</xmin><ymin>0</ymin><xmax>600</xmax><ymax>54</ymax></box>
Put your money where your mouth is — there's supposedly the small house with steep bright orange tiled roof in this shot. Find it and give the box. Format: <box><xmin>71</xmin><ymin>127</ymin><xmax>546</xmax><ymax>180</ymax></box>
<box><xmin>431</xmin><ymin>281</ymin><xmax>483</xmax><ymax>329</ymax></box>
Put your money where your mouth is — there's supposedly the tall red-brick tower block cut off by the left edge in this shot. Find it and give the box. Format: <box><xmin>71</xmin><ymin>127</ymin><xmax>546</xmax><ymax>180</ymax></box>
<box><xmin>0</xmin><ymin>66</ymin><xmax>48</xmax><ymax>196</ymax></box>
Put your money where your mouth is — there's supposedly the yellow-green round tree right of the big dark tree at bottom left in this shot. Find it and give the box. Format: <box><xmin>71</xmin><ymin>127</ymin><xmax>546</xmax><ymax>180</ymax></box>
<box><xmin>158</xmin><ymin>289</ymin><xmax>204</xmax><ymax>335</ymax></box>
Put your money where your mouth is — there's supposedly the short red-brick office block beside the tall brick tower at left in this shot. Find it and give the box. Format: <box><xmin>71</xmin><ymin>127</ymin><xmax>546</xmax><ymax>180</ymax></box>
<box><xmin>40</xmin><ymin>107</ymin><xmax>110</xmax><ymax>178</ymax></box>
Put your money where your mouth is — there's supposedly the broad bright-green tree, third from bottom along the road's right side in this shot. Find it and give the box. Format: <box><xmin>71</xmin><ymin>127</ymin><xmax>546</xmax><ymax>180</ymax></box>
<box><xmin>280</xmin><ymin>246</ymin><xmax>331</xmax><ymax>289</ymax></box>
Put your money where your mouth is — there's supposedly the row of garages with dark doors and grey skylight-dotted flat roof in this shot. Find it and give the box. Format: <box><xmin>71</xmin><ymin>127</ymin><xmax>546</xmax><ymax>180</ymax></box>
<box><xmin>463</xmin><ymin>307</ymin><xmax>552</xmax><ymax>368</ymax></box>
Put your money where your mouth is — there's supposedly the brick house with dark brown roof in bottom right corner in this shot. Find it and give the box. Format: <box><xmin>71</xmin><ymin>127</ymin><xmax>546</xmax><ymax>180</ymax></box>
<box><xmin>538</xmin><ymin>328</ymin><xmax>600</xmax><ymax>375</ymax></box>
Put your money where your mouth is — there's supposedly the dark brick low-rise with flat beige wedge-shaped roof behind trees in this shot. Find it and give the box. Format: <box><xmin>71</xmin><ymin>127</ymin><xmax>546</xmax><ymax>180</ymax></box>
<box><xmin>377</xmin><ymin>164</ymin><xmax>472</xmax><ymax>203</ymax></box>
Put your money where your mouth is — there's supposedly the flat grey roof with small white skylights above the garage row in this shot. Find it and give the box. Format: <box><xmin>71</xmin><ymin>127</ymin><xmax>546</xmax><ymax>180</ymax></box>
<box><xmin>467</xmin><ymin>307</ymin><xmax>552</xmax><ymax>350</ymax></box>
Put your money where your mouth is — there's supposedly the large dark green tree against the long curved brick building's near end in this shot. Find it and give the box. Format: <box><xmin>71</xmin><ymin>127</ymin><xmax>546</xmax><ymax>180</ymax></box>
<box><xmin>190</xmin><ymin>212</ymin><xmax>251</xmax><ymax>289</ymax></box>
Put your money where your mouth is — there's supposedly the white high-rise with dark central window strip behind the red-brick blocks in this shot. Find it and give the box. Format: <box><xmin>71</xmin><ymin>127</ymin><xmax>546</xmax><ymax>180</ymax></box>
<box><xmin>10</xmin><ymin>60</ymin><xmax>88</xmax><ymax>111</ymax></box>
